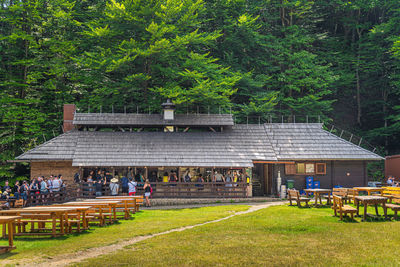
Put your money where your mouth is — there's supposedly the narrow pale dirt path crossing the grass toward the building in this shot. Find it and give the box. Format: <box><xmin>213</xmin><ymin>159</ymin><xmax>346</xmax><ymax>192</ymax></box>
<box><xmin>22</xmin><ymin>202</ymin><xmax>284</xmax><ymax>267</ymax></box>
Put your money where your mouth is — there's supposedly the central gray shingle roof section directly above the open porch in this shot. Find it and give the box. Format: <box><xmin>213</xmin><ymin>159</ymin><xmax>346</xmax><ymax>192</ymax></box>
<box><xmin>72</xmin><ymin>125</ymin><xmax>276</xmax><ymax>167</ymax></box>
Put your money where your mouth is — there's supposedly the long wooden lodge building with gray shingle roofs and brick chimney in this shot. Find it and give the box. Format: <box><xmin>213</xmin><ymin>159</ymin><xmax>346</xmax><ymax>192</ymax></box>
<box><xmin>16</xmin><ymin>101</ymin><xmax>383</xmax><ymax>197</ymax></box>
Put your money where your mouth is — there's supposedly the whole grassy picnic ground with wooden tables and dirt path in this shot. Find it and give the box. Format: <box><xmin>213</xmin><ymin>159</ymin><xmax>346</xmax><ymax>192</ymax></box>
<box><xmin>0</xmin><ymin>187</ymin><xmax>400</xmax><ymax>266</ymax></box>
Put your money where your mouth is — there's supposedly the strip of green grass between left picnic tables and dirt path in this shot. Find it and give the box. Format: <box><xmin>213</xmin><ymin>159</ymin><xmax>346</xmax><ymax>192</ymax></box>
<box><xmin>0</xmin><ymin>205</ymin><xmax>248</xmax><ymax>265</ymax></box>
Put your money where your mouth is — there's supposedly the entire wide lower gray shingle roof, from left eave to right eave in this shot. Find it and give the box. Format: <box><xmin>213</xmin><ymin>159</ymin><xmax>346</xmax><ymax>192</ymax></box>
<box><xmin>17</xmin><ymin>123</ymin><xmax>383</xmax><ymax>167</ymax></box>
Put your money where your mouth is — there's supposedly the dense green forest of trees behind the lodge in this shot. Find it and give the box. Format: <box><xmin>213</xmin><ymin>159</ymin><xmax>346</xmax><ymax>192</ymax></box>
<box><xmin>0</xmin><ymin>0</ymin><xmax>400</xmax><ymax>178</ymax></box>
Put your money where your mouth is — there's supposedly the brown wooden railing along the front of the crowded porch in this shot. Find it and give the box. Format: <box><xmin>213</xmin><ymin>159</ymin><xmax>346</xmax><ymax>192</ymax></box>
<box><xmin>71</xmin><ymin>182</ymin><xmax>248</xmax><ymax>198</ymax></box>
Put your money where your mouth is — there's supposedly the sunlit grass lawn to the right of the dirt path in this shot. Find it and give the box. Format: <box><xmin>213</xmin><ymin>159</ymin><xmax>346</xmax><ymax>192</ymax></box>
<box><xmin>80</xmin><ymin>206</ymin><xmax>400</xmax><ymax>266</ymax></box>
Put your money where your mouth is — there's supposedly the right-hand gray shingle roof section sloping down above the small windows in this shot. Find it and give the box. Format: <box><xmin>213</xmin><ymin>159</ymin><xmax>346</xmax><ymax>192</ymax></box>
<box><xmin>265</xmin><ymin>123</ymin><xmax>383</xmax><ymax>160</ymax></box>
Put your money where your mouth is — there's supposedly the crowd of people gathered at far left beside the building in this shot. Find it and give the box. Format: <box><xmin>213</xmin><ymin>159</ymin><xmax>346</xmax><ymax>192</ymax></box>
<box><xmin>0</xmin><ymin>174</ymin><xmax>66</xmax><ymax>205</ymax></box>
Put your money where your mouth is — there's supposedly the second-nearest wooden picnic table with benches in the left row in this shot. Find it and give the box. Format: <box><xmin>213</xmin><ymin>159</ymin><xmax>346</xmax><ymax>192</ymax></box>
<box><xmin>0</xmin><ymin>206</ymin><xmax>75</xmax><ymax>237</ymax></box>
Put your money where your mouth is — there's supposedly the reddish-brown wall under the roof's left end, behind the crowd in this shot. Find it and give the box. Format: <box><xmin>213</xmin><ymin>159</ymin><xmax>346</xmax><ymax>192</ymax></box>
<box><xmin>31</xmin><ymin>161</ymin><xmax>79</xmax><ymax>184</ymax></box>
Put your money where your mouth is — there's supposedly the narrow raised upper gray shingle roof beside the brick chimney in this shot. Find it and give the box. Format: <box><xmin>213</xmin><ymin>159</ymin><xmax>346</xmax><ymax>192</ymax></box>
<box><xmin>73</xmin><ymin>113</ymin><xmax>234</xmax><ymax>126</ymax></box>
